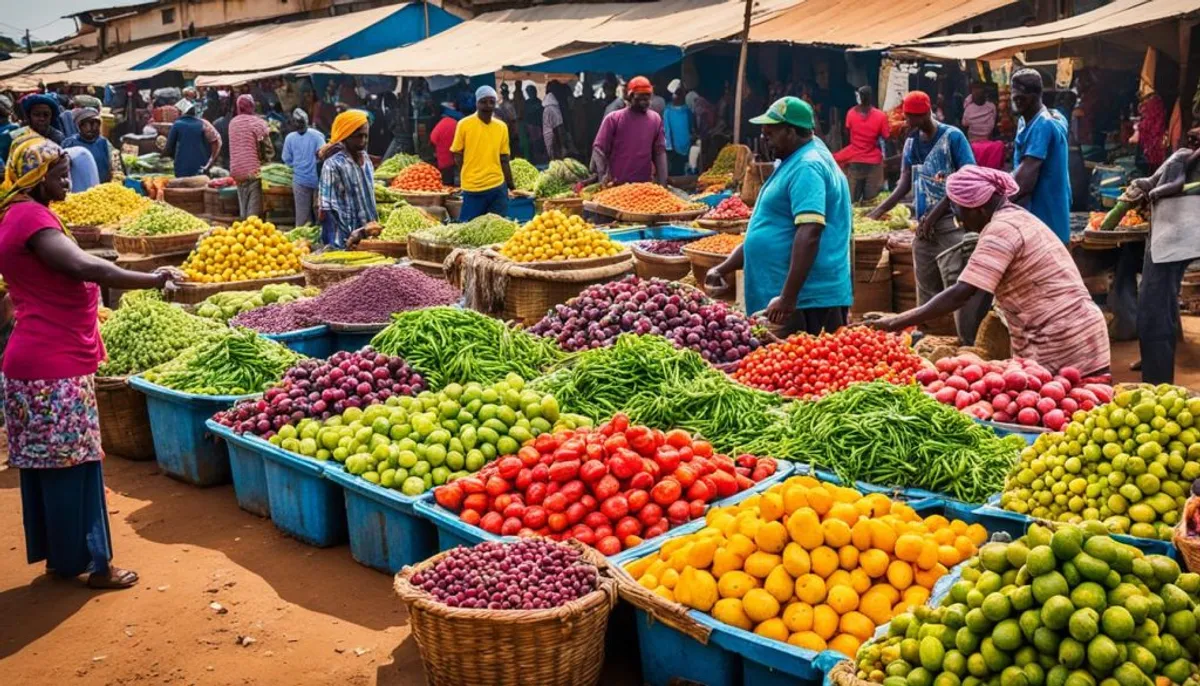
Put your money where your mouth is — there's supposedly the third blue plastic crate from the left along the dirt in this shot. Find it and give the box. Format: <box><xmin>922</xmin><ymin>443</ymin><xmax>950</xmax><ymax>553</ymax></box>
<box><xmin>250</xmin><ymin>438</ymin><xmax>347</xmax><ymax>548</ymax></box>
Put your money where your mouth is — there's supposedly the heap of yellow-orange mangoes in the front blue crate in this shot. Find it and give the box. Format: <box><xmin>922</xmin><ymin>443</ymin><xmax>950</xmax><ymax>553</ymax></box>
<box><xmin>625</xmin><ymin>476</ymin><xmax>988</xmax><ymax>652</ymax></box>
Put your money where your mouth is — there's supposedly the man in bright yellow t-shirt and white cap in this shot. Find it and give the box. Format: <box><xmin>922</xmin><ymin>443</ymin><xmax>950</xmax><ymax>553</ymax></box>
<box><xmin>450</xmin><ymin>86</ymin><xmax>514</xmax><ymax>222</ymax></box>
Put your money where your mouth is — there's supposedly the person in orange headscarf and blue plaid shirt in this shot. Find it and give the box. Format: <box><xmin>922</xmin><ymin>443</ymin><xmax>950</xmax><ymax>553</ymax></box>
<box><xmin>317</xmin><ymin>109</ymin><xmax>379</xmax><ymax>248</ymax></box>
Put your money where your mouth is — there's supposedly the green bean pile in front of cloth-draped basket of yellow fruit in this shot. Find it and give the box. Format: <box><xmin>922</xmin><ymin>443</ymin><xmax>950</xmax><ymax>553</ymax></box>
<box><xmin>371</xmin><ymin>307</ymin><xmax>564</xmax><ymax>389</ymax></box>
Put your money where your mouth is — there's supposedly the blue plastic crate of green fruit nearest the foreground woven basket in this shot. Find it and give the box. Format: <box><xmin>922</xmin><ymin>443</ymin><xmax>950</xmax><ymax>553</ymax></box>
<box><xmin>325</xmin><ymin>462</ymin><xmax>437</xmax><ymax>574</ymax></box>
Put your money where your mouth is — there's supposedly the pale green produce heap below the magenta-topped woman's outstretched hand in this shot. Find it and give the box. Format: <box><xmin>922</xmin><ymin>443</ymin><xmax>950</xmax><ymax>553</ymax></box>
<box><xmin>96</xmin><ymin>290</ymin><xmax>223</xmax><ymax>377</ymax></box>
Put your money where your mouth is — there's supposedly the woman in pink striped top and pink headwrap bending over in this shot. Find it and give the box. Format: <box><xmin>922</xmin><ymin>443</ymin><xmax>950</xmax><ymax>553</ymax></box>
<box><xmin>874</xmin><ymin>164</ymin><xmax>1111</xmax><ymax>377</ymax></box>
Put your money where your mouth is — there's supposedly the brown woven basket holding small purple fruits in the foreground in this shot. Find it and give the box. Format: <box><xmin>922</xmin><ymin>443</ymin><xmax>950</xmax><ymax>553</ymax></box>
<box><xmin>395</xmin><ymin>543</ymin><xmax>618</xmax><ymax>686</ymax></box>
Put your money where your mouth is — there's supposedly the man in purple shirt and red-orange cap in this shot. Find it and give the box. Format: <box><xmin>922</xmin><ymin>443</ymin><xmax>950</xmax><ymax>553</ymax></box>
<box><xmin>592</xmin><ymin>77</ymin><xmax>667</xmax><ymax>185</ymax></box>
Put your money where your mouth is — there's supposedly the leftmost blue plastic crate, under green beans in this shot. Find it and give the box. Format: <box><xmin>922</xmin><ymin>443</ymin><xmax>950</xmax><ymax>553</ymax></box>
<box><xmin>128</xmin><ymin>375</ymin><xmax>257</xmax><ymax>486</ymax></box>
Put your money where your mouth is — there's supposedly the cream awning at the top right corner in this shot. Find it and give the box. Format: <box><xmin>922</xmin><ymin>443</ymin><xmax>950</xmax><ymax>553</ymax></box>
<box><xmin>888</xmin><ymin>0</ymin><xmax>1200</xmax><ymax>60</ymax></box>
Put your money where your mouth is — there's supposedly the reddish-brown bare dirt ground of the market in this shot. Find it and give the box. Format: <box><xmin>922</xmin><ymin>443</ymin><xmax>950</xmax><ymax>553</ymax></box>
<box><xmin>0</xmin><ymin>318</ymin><xmax>1200</xmax><ymax>686</ymax></box>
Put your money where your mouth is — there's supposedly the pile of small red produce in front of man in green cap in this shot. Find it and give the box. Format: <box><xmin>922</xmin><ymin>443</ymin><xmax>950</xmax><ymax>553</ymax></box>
<box><xmin>733</xmin><ymin>326</ymin><xmax>924</xmax><ymax>398</ymax></box>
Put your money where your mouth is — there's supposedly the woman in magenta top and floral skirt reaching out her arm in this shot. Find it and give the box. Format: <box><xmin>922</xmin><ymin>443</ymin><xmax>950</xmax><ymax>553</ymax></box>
<box><xmin>0</xmin><ymin>134</ymin><xmax>178</xmax><ymax>589</ymax></box>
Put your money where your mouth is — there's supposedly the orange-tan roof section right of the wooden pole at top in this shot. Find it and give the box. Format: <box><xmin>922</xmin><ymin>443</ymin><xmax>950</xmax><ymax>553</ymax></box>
<box><xmin>750</xmin><ymin>0</ymin><xmax>1016</xmax><ymax>48</ymax></box>
